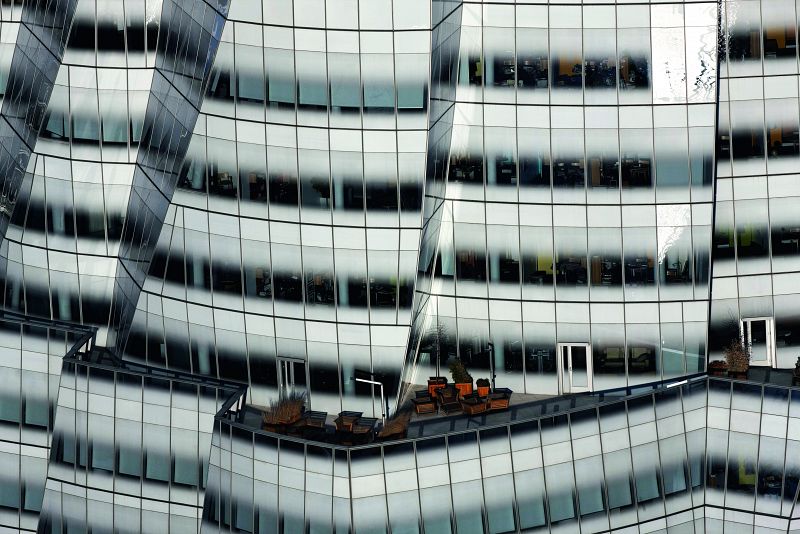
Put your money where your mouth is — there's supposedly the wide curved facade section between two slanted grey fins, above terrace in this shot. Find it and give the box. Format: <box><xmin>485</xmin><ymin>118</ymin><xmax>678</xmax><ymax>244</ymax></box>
<box><xmin>116</xmin><ymin>2</ymin><xmax>444</xmax><ymax>411</ymax></box>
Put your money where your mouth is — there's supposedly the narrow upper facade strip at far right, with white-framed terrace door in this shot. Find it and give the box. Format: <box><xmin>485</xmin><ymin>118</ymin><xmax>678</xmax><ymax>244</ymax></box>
<box><xmin>709</xmin><ymin>2</ymin><xmax>800</xmax><ymax>367</ymax></box>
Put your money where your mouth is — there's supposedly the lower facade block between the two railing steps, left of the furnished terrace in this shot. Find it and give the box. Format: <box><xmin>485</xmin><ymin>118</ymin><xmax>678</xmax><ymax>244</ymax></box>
<box><xmin>38</xmin><ymin>355</ymin><xmax>236</xmax><ymax>533</ymax></box>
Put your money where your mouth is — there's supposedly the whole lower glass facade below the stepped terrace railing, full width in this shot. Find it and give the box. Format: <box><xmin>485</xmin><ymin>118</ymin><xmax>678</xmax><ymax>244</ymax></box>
<box><xmin>0</xmin><ymin>316</ymin><xmax>800</xmax><ymax>533</ymax></box>
